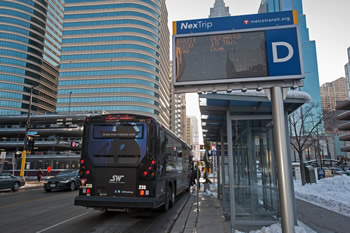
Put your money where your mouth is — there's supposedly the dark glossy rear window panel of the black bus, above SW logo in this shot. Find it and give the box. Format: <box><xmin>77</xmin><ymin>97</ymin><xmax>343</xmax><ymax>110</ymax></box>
<box><xmin>88</xmin><ymin>122</ymin><xmax>147</xmax><ymax>166</ymax></box>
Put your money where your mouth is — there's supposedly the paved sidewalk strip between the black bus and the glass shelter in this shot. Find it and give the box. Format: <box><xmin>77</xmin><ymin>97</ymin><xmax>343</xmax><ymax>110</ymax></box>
<box><xmin>170</xmin><ymin>180</ymin><xmax>230</xmax><ymax>233</ymax></box>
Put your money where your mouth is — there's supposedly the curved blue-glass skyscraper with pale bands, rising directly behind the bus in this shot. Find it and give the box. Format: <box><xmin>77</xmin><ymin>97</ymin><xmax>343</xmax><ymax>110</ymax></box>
<box><xmin>57</xmin><ymin>0</ymin><xmax>170</xmax><ymax>126</ymax></box>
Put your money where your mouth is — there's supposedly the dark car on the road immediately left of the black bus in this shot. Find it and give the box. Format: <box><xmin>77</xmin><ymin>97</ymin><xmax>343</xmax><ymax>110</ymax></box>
<box><xmin>44</xmin><ymin>170</ymin><xmax>80</xmax><ymax>192</ymax></box>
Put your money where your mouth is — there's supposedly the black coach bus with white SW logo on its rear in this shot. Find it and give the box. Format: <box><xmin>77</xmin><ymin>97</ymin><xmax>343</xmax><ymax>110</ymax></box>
<box><xmin>74</xmin><ymin>114</ymin><xmax>192</xmax><ymax>211</ymax></box>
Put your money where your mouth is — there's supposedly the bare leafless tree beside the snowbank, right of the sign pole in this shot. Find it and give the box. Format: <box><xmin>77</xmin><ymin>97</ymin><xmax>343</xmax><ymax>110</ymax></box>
<box><xmin>289</xmin><ymin>103</ymin><xmax>323</xmax><ymax>185</ymax></box>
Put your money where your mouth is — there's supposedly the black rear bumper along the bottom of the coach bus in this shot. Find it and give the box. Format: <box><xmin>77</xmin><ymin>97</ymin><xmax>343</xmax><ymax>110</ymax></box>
<box><xmin>74</xmin><ymin>196</ymin><xmax>158</xmax><ymax>208</ymax></box>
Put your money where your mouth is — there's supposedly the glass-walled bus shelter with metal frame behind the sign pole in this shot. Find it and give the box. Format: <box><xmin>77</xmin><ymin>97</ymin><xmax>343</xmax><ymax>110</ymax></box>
<box><xmin>199</xmin><ymin>91</ymin><xmax>310</xmax><ymax>227</ymax></box>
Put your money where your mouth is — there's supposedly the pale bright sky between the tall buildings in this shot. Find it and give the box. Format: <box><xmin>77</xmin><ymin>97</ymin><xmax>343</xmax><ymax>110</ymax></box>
<box><xmin>166</xmin><ymin>0</ymin><xmax>350</xmax><ymax>85</ymax></box>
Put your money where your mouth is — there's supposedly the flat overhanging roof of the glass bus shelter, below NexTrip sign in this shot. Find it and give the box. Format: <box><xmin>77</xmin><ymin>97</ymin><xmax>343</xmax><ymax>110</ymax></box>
<box><xmin>199</xmin><ymin>91</ymin><xmax>311</xmax><ymax>142</ymax></box>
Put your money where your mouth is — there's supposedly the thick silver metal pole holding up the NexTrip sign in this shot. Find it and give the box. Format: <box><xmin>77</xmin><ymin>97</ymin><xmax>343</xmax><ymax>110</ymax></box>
<box><xmin>271</xmin><ymin>87</ymin><xmax>295</xmax><ymax>233</ymax></box>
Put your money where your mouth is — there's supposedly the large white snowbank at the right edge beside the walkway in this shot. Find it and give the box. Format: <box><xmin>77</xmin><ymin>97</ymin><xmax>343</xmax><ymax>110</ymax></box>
<box><xmin>294</xmin><ymin>175</ymin><xmax>350</xmax><ymax>217</ymax></box>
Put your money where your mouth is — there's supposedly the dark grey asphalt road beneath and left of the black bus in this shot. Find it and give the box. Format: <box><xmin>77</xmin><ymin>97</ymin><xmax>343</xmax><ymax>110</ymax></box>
<box><xmin>0</xmin><ymin>189</ymin><xmax>189</xmax><ymax>233</ymax></box>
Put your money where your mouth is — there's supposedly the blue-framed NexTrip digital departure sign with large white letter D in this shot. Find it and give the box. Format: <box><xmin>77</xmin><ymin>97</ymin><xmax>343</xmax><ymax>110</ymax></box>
<box><xmin>173</xmin><ymin>11</ymin><xmax>304</xmax><ymax>86</ymax></box>
